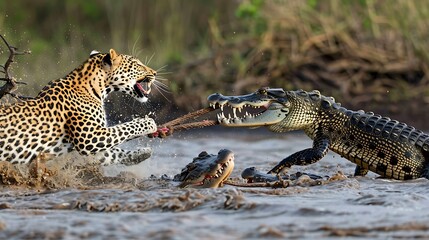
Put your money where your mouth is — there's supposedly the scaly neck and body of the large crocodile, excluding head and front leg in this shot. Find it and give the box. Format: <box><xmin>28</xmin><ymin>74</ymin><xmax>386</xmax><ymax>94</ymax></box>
<box><xmin>278</xmin><ymin>91</ymin><xmax>429</xmax><ymax>179</ymax></box>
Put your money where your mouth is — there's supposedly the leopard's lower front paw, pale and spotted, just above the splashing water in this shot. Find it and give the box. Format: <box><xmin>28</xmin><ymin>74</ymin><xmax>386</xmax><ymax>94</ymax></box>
<box><xmin>95</xmin><ymin>147</ymin><xmax>152</xmax><ymax>166</ymax></box>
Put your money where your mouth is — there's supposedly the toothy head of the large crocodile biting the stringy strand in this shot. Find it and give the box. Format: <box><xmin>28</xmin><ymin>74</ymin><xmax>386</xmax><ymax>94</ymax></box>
<box><xmin>207</xmin><ymin>88</ymin><xmax>290</xmax><ymax>127</ymax></box>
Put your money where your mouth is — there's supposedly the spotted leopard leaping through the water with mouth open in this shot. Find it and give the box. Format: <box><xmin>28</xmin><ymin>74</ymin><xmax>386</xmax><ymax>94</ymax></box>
<box><xmin>0</xmin><ymin>49</ymin><xmax>157</xmax><ymax>165</ymax></box>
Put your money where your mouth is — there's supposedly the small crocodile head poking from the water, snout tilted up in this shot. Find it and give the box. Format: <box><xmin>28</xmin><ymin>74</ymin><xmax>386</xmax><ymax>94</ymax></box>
<box><xmin>174</xmin><ymin>149</ymin><xmax>234</xmax><ymax>188</ymax></box>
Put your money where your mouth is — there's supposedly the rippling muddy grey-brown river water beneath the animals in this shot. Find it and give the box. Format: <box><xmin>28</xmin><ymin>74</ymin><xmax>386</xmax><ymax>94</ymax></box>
<box><xmin>0</xmin><ymin>129</ymin><xmax>429</xmax><ymax>239</ymax></box>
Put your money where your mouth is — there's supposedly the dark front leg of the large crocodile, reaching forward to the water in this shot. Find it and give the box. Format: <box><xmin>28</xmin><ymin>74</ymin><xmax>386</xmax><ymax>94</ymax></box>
<box><xmin>268</xmin><ymin>134</ymin><xmax>330</xmax><ymax>174</ymax></box>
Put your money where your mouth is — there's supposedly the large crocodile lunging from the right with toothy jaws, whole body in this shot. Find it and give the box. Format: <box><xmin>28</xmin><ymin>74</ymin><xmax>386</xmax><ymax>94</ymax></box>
<box><xmin>207</xmin><ymin>87</ymin><xmax>429</xmax><ymax>180</ymax></box>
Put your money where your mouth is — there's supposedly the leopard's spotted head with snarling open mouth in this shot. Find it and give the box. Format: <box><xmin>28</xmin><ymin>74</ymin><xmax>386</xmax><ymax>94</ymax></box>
<box><xmin>102</xmin><ymin>49</ymin><xmax>156</xmax><ymax>102</ymax></box>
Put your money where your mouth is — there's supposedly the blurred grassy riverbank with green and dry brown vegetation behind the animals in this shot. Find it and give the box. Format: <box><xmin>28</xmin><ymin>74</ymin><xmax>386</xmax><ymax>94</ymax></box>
<box><xmin>0</xmin><ymin>0</ymin><xmax>429</xmax><ymax>129</ymax></box>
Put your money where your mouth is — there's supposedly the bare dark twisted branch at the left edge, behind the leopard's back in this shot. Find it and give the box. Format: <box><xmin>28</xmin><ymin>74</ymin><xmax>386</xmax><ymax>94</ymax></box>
<box><xmin>0</xmin><ymin>35</ymin><xmax>31</xmax><ymax>100</ymax></box>
